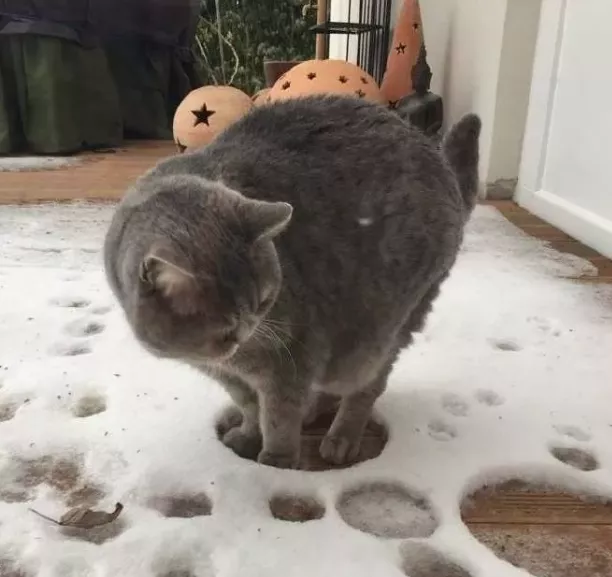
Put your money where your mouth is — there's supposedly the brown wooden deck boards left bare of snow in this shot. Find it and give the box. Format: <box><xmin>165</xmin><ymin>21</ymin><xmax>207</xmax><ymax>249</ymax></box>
<box><xmin>0</xmin><ymin>142</ymin><xmax>612</xmax><ymax>577</ymax></box>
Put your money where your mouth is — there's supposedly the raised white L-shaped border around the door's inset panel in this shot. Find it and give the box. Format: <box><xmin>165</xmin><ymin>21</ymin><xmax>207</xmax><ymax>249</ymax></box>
<box><xmin>515</xmin><ymin>0</ymin><xmax>612</xmax><ymax>258</ymax></box>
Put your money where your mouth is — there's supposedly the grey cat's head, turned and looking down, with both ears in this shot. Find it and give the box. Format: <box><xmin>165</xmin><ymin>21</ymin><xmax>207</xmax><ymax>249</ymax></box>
<box><xmin>120</xmin><ymin>176</ymin><xmax>292</xmax><ymax>362</ymax></box>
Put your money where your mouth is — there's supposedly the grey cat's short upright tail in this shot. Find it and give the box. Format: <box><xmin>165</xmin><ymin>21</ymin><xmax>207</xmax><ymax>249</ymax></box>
<box><xmin>442</xmin><ymin>114</ymin><xmax>482</xmax><ymax>212</ymax></box>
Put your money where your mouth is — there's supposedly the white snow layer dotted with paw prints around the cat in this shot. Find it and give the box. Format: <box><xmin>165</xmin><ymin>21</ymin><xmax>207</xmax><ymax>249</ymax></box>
<box><xmin>0</xmin><ymin>205</ymin><xmax>612</xmax><ymax>577</ymax></box>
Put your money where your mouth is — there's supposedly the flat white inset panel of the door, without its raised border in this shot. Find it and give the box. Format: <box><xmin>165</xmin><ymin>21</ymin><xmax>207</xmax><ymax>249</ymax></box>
<box><xmin>543</xmin><ymin>0</ymin><xmax>612</xmax><ymax>221</ymax></box>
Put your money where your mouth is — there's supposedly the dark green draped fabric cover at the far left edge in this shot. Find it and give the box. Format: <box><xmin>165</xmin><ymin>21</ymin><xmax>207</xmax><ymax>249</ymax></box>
<box><xmin>0</xmin><ymin>34</ymin><xmax>123</xmax><ymax>154</ymax></box>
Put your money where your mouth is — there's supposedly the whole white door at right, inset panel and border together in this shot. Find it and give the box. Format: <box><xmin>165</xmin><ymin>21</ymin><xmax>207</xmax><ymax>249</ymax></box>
<box><xmin>517</xmin><ymin>0</ymin><xmax>612</xmax><ymax>258</ymax></box>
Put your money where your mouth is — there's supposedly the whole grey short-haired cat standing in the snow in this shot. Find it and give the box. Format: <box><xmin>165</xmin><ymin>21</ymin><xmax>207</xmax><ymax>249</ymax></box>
<box><xmin>105</xmin><ymin>97</ymin><xmax>480</xmax><ymax>468</ymax></box>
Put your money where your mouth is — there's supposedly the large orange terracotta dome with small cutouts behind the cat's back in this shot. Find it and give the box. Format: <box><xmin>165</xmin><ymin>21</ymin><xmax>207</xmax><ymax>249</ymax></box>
<box><xmin>269</xmin><ymin>60</ymin><xmax>384</xmax><ymax>103</ymax></box>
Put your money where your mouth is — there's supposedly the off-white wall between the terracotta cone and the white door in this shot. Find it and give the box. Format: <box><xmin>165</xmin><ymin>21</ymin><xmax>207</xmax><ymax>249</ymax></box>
<box><xmin>330</xmin><ymin>0</ymin><xmax>541</xmax><ymax>194</ymax></box>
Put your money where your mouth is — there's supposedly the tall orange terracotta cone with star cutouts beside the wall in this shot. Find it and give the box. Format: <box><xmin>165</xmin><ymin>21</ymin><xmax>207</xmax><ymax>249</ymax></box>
<box><xmin>380</xmin><ymin>0</ymin><xmax>425</xmax><ymax>108</ymax></box>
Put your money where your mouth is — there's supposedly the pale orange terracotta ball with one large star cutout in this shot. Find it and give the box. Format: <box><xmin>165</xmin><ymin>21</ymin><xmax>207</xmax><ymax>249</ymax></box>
<box><xmin>172</xmin><ymin>86</ymin><xmax>253</xmax><ymax>151</ymax></box>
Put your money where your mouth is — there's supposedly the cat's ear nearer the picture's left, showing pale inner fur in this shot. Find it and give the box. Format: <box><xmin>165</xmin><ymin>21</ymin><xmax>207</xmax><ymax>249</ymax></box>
<box><xmin>140</xmin><ymin>246</ymin><xmax>199</xmax><ymax>316</ymax></box>
